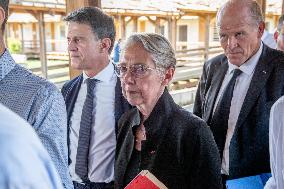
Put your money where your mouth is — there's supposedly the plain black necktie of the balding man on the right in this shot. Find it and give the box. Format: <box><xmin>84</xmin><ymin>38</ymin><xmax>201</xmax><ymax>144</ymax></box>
<box><xmin>210</xmin><ymin>69</ymin><xmax>242</xmax><ymax>158</ymax></box>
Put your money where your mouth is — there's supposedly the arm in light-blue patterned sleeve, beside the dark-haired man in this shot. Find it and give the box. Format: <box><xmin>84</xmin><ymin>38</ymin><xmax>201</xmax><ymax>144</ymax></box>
<box><xmin>29</xmin><ymin>84</ymin><xmax>73</xmax><ymax>189</ymax></box>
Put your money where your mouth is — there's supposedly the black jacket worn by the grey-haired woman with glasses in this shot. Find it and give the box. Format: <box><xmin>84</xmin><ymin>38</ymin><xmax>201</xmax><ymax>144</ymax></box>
<box><xmin>115</xmin><ymin>90</ymin><xmax>222</xmax><ymax>189</ymax></box>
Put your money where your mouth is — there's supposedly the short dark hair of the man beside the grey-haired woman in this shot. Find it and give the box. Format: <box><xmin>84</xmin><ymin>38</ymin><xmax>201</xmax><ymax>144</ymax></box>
<box><xmin>64</xmin><ymin>7</ymin><xmax>115</xmax><ymax>54</ymax></box>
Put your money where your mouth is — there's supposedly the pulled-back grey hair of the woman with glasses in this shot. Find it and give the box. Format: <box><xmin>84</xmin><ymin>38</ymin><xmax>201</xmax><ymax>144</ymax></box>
<box><xmin>121</xmin><ymin>33</ymin><xmax>176</xmax><ymax>70</ymax></box>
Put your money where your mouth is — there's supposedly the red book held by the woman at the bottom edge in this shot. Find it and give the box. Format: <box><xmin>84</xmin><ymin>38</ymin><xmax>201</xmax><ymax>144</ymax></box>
<box><xmin>124</xmin><ymin>170</ymin><xmax>168</xmax><ymax>189</ymax></box>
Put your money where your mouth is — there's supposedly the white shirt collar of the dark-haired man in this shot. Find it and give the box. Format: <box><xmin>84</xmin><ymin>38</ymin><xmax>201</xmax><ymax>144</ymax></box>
<box><xmin>83</xmin><ymin>62</ymin><xmax>115</xmax><ymax>83</ymax></box>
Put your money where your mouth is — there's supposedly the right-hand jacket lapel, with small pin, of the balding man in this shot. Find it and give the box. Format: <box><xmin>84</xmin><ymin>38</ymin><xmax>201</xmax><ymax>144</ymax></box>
<box><xmin>236</xmin><ymin>46</ymin><xmax>273</xmax><ymax>127</ymax></box>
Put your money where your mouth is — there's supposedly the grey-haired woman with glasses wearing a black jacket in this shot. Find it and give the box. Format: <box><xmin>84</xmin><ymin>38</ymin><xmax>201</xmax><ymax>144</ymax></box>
<box><xmin>115</xmin><ymin>33</ymin><xmax>222</xmax><ymax>189</ymax></box>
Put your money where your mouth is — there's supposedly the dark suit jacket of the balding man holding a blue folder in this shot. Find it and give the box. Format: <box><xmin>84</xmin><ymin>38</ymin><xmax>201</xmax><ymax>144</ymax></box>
<box><xmin>193</xmin><ymin>45</ymin><xmax>284</xmax><ymax>178</ymax></box>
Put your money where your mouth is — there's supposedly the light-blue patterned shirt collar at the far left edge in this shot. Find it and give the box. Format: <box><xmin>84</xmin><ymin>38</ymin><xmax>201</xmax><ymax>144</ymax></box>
<box><xmin>0</xmin><ymin>49</ymin><xmax>16</xmax><ymax>80</ymax></box>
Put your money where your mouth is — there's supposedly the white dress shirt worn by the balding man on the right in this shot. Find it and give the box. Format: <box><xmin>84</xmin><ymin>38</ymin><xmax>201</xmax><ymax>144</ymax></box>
<box><xmin>214</xmin><ymin>43</ymin><xmax>263</xmax><ymax>175</ymax></box>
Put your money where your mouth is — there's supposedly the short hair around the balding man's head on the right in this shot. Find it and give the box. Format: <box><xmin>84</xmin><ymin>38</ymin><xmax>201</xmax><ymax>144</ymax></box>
<box><xmin>216</xmin><ymin>0</ymin><xmax>264</xmax><ymax>27</ymax></box>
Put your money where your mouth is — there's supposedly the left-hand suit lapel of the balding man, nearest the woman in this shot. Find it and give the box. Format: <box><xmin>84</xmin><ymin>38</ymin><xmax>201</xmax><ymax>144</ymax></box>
<box><xmin>203</xmin><ymin>60</ymin><xmax>228</xmax><ymax>123</ymax></box>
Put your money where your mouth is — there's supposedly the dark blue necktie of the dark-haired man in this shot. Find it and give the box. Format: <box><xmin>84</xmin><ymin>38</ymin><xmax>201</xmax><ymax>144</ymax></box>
<box><xmin>75</xmin><ymin>78</ymin><xmax>97</xmax><ymax>181</ymax></box>
